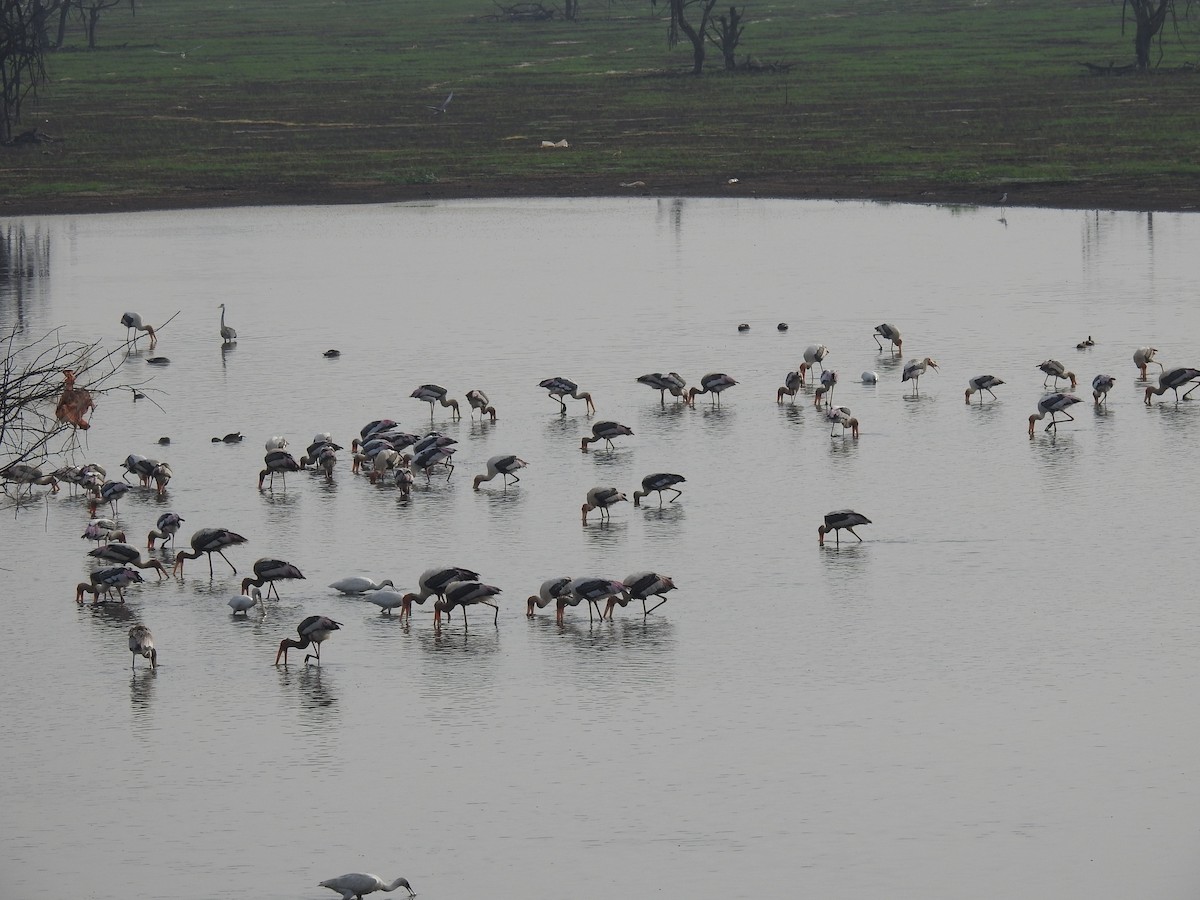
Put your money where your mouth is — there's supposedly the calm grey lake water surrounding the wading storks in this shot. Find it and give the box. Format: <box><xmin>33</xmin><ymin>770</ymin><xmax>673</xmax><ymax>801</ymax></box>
<box><xmin>0</xmin><ymin>199</ymin><xmax>1200</xmax><ymax>900</ymax></box>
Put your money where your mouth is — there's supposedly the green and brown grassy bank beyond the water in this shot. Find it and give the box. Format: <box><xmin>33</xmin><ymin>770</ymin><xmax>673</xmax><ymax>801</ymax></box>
<box><xmin>0</xmin><ymin>0</ymin><xmax>1200</xmax><ymax>212</ymax></box>
